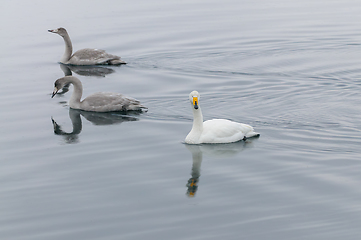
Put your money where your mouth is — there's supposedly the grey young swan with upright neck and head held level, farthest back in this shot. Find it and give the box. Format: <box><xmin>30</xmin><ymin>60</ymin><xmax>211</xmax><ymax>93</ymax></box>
<box><xmin>48</xmin><ymin>27</ymin><xmax>126</xmax><ymax>65</ymax></box>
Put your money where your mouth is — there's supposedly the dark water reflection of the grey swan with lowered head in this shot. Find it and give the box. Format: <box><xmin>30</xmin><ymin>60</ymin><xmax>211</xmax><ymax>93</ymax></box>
<box><xmin>51</xmin><ymin>108</ymin><xmax>138</xmax><ymax>143</ymax></box>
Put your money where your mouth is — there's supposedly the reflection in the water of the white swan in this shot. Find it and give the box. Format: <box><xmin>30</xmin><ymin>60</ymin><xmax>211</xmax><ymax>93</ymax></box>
<box><xmin>185</xmin><ymin>138</ymin><xmax>257</xmax><ymax>197</ymax></box>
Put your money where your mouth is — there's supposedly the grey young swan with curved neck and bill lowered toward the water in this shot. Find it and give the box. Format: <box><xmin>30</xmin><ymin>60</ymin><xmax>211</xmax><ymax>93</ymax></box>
<box><xmin>52</xmin><ymin>76</ymin><xmax>147</xmax><ymax>112</ymax></box>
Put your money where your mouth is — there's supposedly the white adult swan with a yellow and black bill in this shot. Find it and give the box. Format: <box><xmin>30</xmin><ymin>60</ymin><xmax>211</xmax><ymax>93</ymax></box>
<box><xmin>185</xmin><ymin>91</ymin><xmax>259</xmax><ymax>144</ymax></box>
